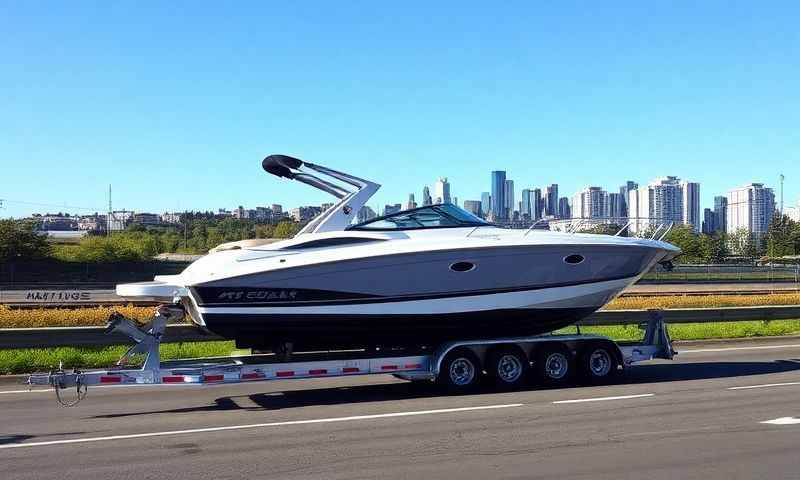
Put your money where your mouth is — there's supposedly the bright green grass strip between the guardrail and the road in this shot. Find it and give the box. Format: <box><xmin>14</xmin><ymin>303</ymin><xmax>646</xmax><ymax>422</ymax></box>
<box><xmin>0</xmin><ymin>319</ymin><xmax>800</xmax><ymax>375</ymax></box>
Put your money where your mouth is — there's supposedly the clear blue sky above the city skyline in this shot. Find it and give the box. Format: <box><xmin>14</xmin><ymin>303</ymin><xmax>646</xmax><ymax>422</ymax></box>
<box><xmin>0</xmin><ymin>0</ymin><xmax>800</xmax><ymax>217</ymax></box>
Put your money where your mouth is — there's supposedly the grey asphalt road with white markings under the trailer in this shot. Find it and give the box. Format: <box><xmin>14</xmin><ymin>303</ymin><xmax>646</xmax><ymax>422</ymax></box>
<box><xmin>0</xmin><ymin>339</ymin><xmax>800</xmax><ymax>480</ymax></box>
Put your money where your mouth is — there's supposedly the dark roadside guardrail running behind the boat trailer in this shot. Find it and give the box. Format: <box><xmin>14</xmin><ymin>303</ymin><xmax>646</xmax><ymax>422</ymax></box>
<box><xmin>0</xmin><ymin>305</ymin><xmax>800</xmax><ymax>349</ymax></box>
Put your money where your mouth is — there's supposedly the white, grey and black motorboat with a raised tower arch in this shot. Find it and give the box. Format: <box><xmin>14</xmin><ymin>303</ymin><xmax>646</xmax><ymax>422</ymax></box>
<box><xmin>116</xmin><ymin>155</ymin><xmax>680</xmax><ymax>351</ymax></box>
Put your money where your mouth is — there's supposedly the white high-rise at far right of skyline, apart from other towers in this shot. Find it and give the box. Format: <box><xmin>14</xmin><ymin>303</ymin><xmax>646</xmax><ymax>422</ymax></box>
<box><xmin>726</xmin><ymin>183</ymin><xmax>775</xmax><ymax>241</ymax></box>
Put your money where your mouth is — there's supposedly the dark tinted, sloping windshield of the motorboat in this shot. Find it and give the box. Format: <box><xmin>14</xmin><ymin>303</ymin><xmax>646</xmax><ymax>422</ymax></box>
<box><xmin>350</xmin><ymin>203</ymin><xmax>488</xmax><ymax>230</ymax></box>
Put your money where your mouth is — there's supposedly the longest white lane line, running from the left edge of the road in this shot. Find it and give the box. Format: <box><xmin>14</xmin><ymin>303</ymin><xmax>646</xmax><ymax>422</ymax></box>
<box><xmin>0</xmin><ymin>403</ymin><xmax>524</xmax><ymax>449</ymax></box>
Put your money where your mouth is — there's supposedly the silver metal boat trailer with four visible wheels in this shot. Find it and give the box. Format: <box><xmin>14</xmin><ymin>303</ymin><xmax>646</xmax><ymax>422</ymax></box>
<box><xmin>28</xmin><ymin>305</ymin><xmax>675</xmax><ymax>406</ymax></box>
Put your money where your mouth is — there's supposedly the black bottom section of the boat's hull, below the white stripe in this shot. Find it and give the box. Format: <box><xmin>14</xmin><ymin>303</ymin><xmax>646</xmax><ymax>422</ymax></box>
<box><xmin>203</xmin><ymin>308</ymin><xmax>596</xmax><ymax>351</ymax></box>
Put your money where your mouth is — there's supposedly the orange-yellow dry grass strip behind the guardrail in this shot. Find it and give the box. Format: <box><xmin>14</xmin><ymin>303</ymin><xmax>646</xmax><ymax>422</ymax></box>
<box><xmin>0</xmin><ymin>293</ymin><xmax>800</xmax><ymax>328</ymax></box>
